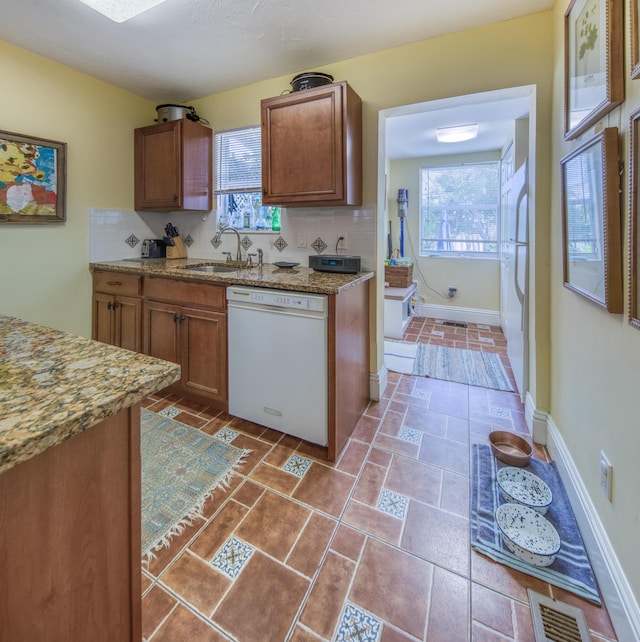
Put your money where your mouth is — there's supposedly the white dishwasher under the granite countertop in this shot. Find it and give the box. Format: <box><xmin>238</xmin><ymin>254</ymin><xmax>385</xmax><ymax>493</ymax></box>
<box><xmin>227</xmin><ymin>286</ymin><xmax>328</xmax><ymax>446</ymax></box>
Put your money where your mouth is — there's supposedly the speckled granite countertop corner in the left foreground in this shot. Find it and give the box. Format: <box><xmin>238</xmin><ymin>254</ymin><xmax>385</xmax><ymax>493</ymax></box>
<box><xmin>0</xmin><ymin>314</ymin><xmax>180</xmax><ymax>473</ymax></box>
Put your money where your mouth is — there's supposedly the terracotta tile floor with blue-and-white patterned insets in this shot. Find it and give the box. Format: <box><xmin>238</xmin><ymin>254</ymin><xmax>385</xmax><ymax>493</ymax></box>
<box><xmin>142</xmin><ymin>318</ymin><xmax>615</xmax><ymax>642</ymax></box>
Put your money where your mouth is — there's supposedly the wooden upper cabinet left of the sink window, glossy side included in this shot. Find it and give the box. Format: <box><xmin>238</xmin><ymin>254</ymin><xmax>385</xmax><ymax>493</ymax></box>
<box><xmin>135</xmin><ymin>118</ymin><xmax>213</xmax><ymax>212</ymax></box>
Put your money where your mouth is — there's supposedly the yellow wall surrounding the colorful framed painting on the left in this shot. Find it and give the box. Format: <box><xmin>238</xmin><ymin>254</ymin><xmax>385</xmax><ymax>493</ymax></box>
<box><xmin>0</xmin><ymin>42</ymin><xmax>155</xmax><ymax>336</ymax></box>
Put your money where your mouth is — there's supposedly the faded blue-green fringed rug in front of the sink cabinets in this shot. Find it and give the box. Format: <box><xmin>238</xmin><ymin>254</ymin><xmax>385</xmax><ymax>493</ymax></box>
<box><xmin>140</xmin><ymin>409</ymin><xmax>250</xmax><ymax>561</ymax></box>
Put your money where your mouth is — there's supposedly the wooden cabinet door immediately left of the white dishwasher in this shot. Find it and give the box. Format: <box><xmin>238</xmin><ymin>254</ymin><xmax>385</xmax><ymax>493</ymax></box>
<box><xmin>180</xmin><ymin>308</ymin><xmax>227</xmax><ymax>402</ymax></box>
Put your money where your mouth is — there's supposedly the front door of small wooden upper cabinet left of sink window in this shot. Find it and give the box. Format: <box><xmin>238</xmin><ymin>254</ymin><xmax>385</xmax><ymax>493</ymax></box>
<box><xmin>135</xmin><ymin>120</ymin><xmax>182</xmax><ymax>209</ymax></box>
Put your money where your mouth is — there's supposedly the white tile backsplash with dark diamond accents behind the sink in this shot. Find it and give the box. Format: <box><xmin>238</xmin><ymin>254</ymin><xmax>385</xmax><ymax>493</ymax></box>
<box><xmin>89</xmin><ymin>208</ymin><xmax>376</xmax><ymax>269</ymax></box>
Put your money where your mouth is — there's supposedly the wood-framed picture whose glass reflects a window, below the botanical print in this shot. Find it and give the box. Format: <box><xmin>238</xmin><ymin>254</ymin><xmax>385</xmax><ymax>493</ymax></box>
<box><xmin>560</xmin><ymin>127</ymin><xmax>623</xmax><ymax>313</ymax></box>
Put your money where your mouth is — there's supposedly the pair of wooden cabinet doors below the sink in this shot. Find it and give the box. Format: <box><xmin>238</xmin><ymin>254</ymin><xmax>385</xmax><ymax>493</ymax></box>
<box><xmin>144</xmin><ymin>300</ymin><xmax>227</xmax><ymax>409</ymax></box>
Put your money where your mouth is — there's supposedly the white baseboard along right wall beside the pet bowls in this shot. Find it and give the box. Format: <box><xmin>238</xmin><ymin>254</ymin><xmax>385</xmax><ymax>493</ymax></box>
<box><xmin>546</xmin><ymin>415</ymin><xmax>640</xmax><ymax>642</ymax></box>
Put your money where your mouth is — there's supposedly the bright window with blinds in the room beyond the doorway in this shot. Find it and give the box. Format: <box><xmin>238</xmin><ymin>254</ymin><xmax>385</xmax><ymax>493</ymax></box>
<box><xmin>420</xmin><ymin>161</ymin><xmax>500</xmax><ymax>257</ymax></box>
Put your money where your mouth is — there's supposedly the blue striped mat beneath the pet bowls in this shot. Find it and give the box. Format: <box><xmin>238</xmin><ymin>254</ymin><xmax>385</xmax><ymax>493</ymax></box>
<box><xmin>471</xmin><ymin>444</ymin><xmax>601</xmax><ymax>604</ymax></box>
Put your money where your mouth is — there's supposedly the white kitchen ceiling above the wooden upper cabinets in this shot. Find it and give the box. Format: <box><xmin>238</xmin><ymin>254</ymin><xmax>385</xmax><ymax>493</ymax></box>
<box><xmin>0</xmin><ymin>0</ymin><xmax>553</xmax><ymax>155</ymax></box>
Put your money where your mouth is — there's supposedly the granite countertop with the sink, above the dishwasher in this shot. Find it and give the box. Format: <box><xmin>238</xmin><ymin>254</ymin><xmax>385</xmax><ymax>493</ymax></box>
<box><xmin>90</xmin><ymin>259</ymin><xmax>374</xmax><ymax>294</ymax></box>
